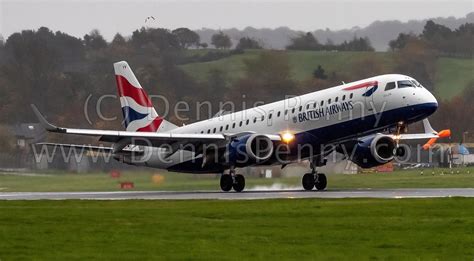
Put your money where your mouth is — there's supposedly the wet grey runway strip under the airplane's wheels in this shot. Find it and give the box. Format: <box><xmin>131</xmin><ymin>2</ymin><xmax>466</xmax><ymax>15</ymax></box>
<box><xmin>0</xmin><ymin>188</ymin><xmax>474</xmax><ymax>200</ymax></box>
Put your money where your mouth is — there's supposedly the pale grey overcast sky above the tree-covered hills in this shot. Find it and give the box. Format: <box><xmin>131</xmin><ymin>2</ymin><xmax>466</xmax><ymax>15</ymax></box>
<box><xmin>0</xmin><ymin>0</ymin><xmax>474</xmax><ymax>40</ymax></box>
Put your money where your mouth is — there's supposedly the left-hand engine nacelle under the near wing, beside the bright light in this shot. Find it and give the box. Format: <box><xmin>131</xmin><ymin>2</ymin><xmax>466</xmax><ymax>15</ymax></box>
<box><xmin>225</xmin><ymin>134</ymin><xmax>274</xmax><ymax>166</ymax></box>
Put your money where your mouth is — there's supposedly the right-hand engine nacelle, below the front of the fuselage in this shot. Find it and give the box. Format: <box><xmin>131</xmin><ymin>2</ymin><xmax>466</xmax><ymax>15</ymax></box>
<box><xmin>349</xmin><ymin>134</ymin><xmax>397</xmax><ymax>168</ymax></box>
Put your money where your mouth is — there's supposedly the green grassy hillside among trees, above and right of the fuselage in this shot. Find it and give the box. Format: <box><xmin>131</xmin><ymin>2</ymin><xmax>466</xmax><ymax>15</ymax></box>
<box><xmin>181</xmin><ymin>50</ymin><xmax>474</xmax><ymax>99</ymax></box>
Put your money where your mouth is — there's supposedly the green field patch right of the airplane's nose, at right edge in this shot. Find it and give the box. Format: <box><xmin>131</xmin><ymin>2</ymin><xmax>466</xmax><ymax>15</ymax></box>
<box><xmin>435</xmin><ymin>57</ymin><xmax>474</xmax><ymax>100</ymax></box>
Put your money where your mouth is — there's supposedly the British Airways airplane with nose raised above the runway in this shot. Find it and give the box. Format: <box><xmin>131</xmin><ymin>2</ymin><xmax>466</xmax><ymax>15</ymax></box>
<box><xmin>32</xmin><ymin>61</ymin><xmax>440</xmax><ymax>192</ymax></box>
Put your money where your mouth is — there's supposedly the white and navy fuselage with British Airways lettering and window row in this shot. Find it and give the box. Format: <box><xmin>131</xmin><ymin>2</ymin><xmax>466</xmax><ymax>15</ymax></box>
<box><xmin>141</xmin><ymin>74</ymin><xmax>437</xmax><ymax>169</ymax></box>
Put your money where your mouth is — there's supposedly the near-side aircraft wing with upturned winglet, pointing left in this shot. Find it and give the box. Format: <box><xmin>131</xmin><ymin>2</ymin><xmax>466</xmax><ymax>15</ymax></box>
<box><xmin>31</xmin><ymin>104</ymin><xmax>281</xmax><ymax>147</ymax></box>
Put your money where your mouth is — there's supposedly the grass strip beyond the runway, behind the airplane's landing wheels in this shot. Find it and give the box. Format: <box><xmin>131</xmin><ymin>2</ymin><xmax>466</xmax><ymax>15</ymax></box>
<box><xmin>0</xmin><ymin>167</ymin><xmax>474</xmax><ymax>192</ymax></box>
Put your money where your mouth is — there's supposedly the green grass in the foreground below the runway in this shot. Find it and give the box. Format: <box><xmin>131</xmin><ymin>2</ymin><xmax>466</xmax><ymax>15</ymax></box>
<box><xmin>0</xmin><ymin>198</ymin><xmax>474</xmax><ymax>260</ymax></box>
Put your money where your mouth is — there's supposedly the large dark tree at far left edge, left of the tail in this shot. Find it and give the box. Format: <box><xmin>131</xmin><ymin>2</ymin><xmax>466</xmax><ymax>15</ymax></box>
<box><xmin>0</xmin><ymin>27</ymin><xmax>62</xmax><ymax>122</ymax></box>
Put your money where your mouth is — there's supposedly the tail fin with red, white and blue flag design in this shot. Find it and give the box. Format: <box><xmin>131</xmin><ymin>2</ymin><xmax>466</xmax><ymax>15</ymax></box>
<box><xmin>114</xmin><ymin>61</ymin><xmax>176</xmax><ymax>132</ymax></box>
